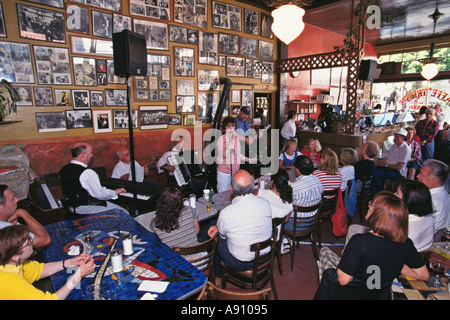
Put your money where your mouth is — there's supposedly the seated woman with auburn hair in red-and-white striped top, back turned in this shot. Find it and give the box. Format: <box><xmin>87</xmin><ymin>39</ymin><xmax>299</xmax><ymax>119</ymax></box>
<box><xmin>313</xmin><ymin>148</ymin><xmax>342</xmax><ymax>195</ymax></box>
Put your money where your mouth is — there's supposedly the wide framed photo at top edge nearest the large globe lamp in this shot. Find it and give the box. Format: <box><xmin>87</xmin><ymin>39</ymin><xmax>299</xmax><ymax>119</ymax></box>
<box><xmin>212</xmin><ymin>1</ymin><xmax>242</xmax><ymax>31</ymax></box>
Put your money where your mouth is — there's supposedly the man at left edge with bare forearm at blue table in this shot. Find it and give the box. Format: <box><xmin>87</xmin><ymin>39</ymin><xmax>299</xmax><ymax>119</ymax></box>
<box><xmin>0</xmin><ymin>184</ymin><xmax>51</xmax><ymax>249</ymax></box>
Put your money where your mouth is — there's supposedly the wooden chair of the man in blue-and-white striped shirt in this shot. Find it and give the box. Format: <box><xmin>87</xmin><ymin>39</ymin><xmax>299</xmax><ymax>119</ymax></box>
<box><xmin>283</xmin><ymin>201</ymin><xmax>322</xmax><ymax>271</ymax></box>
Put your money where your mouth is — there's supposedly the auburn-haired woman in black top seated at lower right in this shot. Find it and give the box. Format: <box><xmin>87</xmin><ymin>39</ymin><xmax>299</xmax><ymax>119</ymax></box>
<box><xmin>314</xmin><ymin>191</ymin><xmax>429</xmax><ymax>300</ymax></box>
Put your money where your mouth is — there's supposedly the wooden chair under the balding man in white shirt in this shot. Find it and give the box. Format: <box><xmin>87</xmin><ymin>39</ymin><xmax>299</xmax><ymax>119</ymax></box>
<box><xmin>221</xmin><ymin>231</ymin><xmax>278</xmax><ymax>300</ymax></box>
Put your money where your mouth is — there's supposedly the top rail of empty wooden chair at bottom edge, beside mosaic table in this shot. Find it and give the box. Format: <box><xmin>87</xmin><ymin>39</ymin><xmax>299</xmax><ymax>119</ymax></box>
<box><xmin>197</xmin><ymin>281</ymin><xmax>272</xmax><ymax>300</ymax></box>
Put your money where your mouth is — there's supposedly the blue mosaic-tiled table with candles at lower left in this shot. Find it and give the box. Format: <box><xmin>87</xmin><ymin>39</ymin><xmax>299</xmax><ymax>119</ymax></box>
<box><xmin>43</xmin><ymin>210</ymin><xmax>207</xmax><ymax>300</ymax></box>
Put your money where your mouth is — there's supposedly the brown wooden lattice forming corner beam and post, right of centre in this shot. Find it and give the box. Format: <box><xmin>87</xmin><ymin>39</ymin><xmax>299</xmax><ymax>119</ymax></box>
<box><xmin>276</xmin><ymin>50</ymin><xmax>361</xmax><ymax>134</ymax></box>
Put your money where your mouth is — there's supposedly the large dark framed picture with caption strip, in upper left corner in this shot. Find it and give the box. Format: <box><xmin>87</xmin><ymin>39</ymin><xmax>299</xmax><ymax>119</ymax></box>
<box><xmin>17</xmin><ymin>3</ymin><xmax>66</xmax><ymax>43</ymax></box>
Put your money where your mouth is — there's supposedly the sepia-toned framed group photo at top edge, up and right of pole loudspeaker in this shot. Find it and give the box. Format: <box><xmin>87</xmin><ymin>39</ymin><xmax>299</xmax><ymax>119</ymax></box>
<box><xmin>173</xmin><ymin>0</ymin><xmax>208</xmax><ymax>28</ymax></box>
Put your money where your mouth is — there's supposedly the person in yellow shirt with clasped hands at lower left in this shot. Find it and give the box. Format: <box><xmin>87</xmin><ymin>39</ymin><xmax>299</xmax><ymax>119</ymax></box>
<box><xmin>0</xmin><ymin>225</ymin><xmax>95</xmax><ymax>300</ymax></box>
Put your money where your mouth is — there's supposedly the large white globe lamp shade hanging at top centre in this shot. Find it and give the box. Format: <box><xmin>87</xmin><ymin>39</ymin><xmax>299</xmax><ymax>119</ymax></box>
<box><xmin>272</xmin><ymin>4</ymin><xmax>305</xmax><ymax>44</ymax></box>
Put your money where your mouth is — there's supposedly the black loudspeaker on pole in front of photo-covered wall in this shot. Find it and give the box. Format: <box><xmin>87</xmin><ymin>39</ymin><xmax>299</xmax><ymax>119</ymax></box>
<box><xmin>113</xmin><ymin>29</ymin><xmax>147</xmax><ymax>77</ymax></box>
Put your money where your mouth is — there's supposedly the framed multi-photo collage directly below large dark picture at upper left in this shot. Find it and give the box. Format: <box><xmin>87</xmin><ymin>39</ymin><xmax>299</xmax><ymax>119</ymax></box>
<box><xmin>33</xmin><ymin>46</ymin><xmax>72</xmax><ymax>85</ymax></box>
